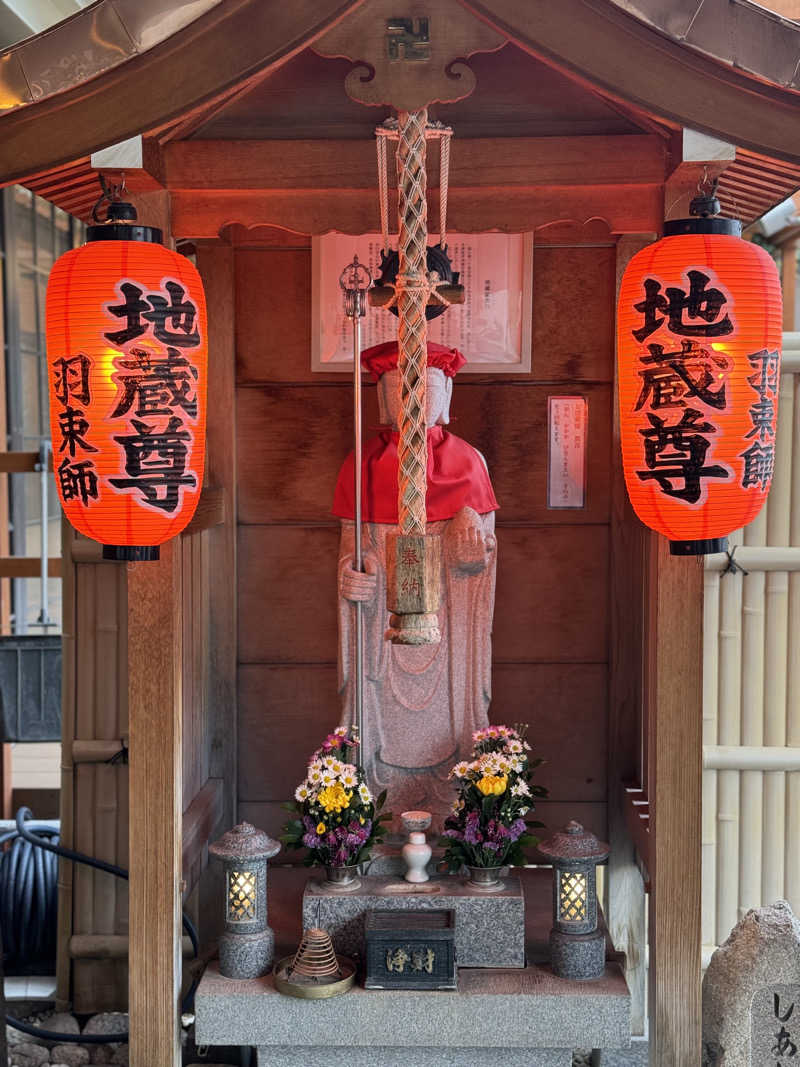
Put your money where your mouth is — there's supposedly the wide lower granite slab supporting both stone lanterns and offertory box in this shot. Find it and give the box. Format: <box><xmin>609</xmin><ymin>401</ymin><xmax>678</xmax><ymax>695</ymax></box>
<box><xmin>195</xmin><ymin>869</ymin><xmax>630</xmax><ymax>1067</ymax></box>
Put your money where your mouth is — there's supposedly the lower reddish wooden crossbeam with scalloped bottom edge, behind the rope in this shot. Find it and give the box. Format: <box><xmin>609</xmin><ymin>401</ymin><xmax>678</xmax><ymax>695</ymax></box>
<box><xmin>172</xmin><ymin>184</ymin><xmax>663</xmax><ymax>238</ymax></box>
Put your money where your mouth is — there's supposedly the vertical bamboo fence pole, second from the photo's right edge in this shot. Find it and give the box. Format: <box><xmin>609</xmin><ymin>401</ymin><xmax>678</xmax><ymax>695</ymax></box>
<box><xmin>762</xmin><ymin>375</ymin><xmax>794</xmax><ymax>904</ymax></box>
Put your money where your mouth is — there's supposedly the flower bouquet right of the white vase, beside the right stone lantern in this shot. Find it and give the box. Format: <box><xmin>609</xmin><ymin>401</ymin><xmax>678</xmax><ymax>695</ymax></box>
<box><xmin>441</xmin><ymin>727</ymin><xmax>547</xmax><ymax>871</ymax></box>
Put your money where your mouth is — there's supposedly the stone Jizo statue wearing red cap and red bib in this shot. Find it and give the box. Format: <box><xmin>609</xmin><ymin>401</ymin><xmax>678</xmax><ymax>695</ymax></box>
<box><xmin>333</xmin><ymin>343</ymin><xmax>497</xmax><ymax>829</ymax></box>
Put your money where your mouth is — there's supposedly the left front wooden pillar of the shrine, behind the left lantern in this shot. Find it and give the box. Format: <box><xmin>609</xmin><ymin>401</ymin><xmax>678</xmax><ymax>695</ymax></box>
<box><xmin>127</xmin><ymin>192</ymin><xmax>183</xmax><ymax>1067</ymax></box>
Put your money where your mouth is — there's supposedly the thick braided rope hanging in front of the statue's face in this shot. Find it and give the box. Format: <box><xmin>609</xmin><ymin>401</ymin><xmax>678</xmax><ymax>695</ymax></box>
<box><xmin>396</xmin><ymin>108</ymin><xmax>429</xmax><ymax>534</ymax></box>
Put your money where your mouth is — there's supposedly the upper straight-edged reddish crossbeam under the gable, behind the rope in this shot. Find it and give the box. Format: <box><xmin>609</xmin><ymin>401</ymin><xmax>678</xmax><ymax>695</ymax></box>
<box><xmin>164</xmin><ymin>134</ymin><xmax>667</xmax><ymax>191</ymax></box>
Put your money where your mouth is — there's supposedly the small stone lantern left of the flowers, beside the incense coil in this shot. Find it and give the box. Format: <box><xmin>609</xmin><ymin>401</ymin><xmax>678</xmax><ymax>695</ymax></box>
<box><xmin>208</xmin><ymin>823</ymin><xmax>281</xmax><ymax>978</ymax></box>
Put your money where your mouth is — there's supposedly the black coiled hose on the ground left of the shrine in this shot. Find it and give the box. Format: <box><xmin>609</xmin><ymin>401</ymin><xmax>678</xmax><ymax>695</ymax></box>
<box><xmin>5</xmin><ymin>808</ymin><xmax>199</xmax><ymax>1045</ymax></box>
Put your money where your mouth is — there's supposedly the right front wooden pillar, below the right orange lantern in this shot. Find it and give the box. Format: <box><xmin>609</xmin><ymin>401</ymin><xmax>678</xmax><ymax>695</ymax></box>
<box><xmin>645</xmin><ymin>534</ymin><xmax>703</xmax><ymax>1067</ymax></box>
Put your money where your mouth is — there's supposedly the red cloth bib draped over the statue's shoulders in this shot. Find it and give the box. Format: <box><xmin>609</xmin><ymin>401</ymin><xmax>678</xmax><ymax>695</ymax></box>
<box><xmin>333</xmin><ymin>426</ymin><xmax>498</xmax><ymax>525</ymax></box>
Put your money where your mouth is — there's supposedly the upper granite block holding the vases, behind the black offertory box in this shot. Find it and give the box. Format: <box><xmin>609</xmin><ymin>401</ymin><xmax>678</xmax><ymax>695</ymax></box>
<box><xmin>303</xmin><ymin>875</ymin><xmax>525</xmax><ymax>967</ymax></box>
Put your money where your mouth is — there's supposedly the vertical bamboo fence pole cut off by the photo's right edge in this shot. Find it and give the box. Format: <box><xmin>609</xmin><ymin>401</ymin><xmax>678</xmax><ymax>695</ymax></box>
<box><xmin>782</xmin><ymin>368</ymin><xmax>800</xmax><ymax>914</ymax></box>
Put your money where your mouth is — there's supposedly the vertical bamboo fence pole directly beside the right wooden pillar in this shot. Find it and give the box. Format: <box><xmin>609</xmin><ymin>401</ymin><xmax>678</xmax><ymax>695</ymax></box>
<box><xmin>701</xmin><ymin>571</ymin><xmax>720</xmax><ymax>944</ymax></box>
